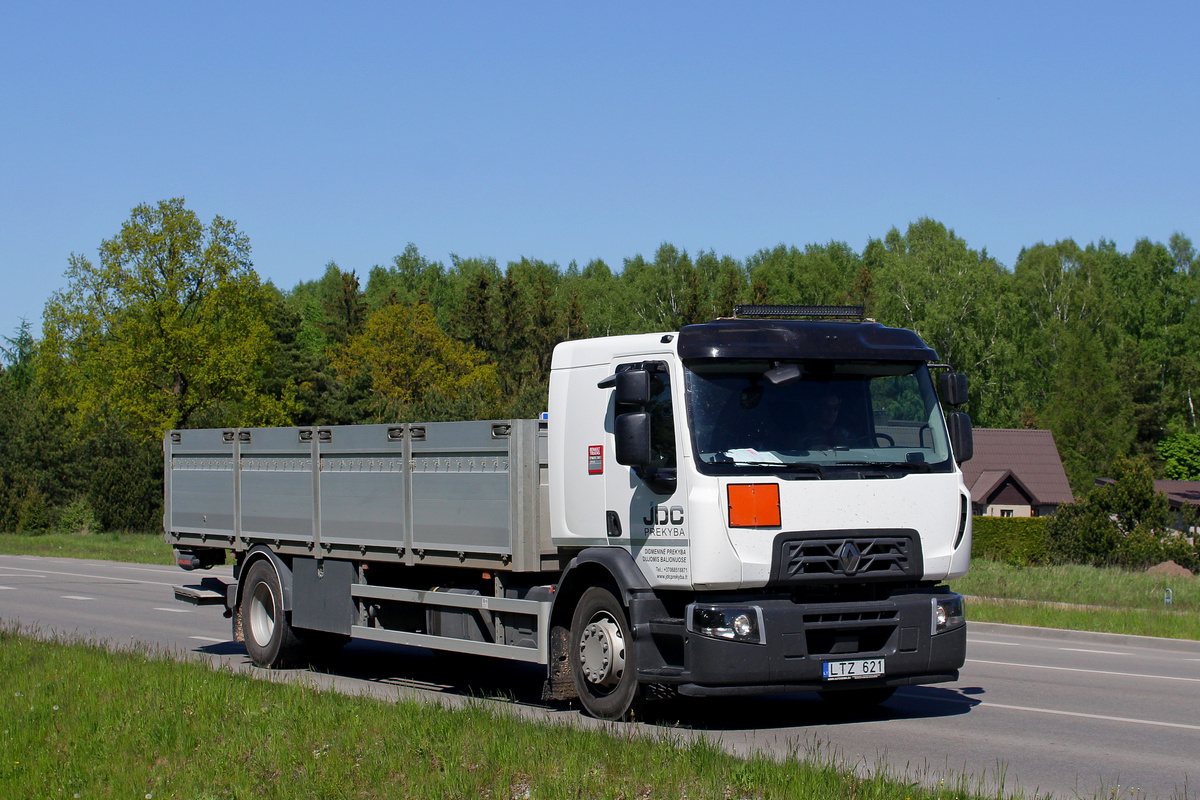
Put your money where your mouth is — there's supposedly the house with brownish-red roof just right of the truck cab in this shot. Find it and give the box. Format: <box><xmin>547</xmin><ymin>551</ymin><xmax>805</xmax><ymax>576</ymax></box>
<box><xmin>962</xmin><ymin>428</ymin><xmax>1075</xmax><ymax>517</ymax></box>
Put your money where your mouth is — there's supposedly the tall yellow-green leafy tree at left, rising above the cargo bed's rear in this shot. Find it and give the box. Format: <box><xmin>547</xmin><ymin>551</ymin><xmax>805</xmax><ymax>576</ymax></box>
<box><xmin>42</xmin><ymin>198</ymin><xmax>292</xmax><ymax>439</ymax></box>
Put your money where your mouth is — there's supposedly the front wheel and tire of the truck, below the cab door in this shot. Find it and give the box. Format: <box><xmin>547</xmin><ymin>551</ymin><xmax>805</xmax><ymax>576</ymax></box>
<box><xmin>568</xmin><ymin>587</ymin><xmax>641</xmax><ymax>720</ymax></box>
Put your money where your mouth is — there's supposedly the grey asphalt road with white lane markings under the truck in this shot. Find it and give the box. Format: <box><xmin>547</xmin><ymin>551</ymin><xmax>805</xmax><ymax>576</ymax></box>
<box><xmin>0</xmin><ymin>555</ymin><xmax>1200</xmax><ymax>798</ymax></box>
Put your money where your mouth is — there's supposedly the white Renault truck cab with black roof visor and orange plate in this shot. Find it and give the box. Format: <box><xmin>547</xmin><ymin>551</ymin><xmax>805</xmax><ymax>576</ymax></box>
<box><xmin>548</xmin><ymin>309</ymin><xmax>971</xmax><ymax>719</ymax></box>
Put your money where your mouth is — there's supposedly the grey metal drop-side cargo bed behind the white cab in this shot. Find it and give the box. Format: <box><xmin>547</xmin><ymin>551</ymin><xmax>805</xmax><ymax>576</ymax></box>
<box><xmin>164</xmin><ymin>420</ymin><xmax>562</xmax><ymax>572</ymax></box>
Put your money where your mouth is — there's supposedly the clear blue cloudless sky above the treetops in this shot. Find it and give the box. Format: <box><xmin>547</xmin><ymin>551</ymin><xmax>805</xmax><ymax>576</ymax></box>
<box><xmin>0</xmin><ymin>1</ymin><xmax>1200</xmax><ymax>335</ymax></box>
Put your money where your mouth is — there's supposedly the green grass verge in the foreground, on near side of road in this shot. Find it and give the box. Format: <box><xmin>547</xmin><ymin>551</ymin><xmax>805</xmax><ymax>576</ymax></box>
<box><xmin>0</xmin><ymin>626</ymin><xmax>1032</xmax><ymax>800</ymax></box>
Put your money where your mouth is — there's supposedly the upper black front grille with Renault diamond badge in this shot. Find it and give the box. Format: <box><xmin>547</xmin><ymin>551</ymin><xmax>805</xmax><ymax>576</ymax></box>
<box><xmin>772</xmin><ymin>530</ymin><xmax>924</xmax><ymax>584</ymax></box>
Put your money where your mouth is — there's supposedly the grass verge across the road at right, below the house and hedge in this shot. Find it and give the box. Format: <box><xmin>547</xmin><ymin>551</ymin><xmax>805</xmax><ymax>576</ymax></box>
<box><xmin>950</xmin><ymin>558</ymin><xmax>1200</xmax><ymax>639</ymax></box>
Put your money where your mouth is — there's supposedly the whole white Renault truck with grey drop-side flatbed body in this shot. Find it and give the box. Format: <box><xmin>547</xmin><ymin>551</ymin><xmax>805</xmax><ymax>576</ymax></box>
<box><xmin>171</xmin><ymin>307</ymin><xmax>971</xmax><ymax>720</ymax></box>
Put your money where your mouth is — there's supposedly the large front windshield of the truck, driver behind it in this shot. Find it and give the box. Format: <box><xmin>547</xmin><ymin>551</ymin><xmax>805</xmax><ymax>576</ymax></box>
<box><xmin>685</xmin><ymin>359</ymin><xmax>953</xmax><ymax>477</ymax></box>
